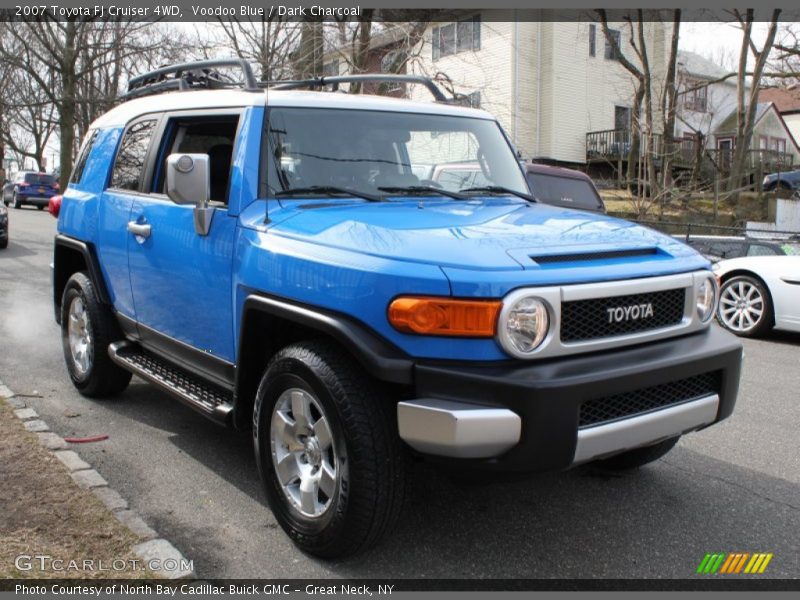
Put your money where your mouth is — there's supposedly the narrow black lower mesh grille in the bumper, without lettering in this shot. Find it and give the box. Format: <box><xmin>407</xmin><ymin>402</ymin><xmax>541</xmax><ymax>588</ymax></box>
<box><xmin>578</xmin><ymin>371</ymin><xmax>720</xmax><ymax>428</ymax></box>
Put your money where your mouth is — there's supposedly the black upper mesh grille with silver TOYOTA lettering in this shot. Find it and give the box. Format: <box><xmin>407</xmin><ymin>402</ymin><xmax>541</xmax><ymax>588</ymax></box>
<box><xmin>561</xmin><ymin>288</ymin><xmax>686</xmax><ymax>343</ymax></box>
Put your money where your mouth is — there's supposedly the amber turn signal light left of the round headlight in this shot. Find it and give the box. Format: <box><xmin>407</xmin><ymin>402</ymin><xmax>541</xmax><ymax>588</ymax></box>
<box><xmin>389</xmin><ymin>296</ymin><xmax>503</xmax><ymax>338</ymax></box>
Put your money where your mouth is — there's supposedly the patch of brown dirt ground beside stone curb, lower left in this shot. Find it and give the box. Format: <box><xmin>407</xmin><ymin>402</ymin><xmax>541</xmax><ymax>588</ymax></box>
<box><xmin>0</xmin><ymin>399</ymin><xmax>151</xmax><ymax>579</ymax></box>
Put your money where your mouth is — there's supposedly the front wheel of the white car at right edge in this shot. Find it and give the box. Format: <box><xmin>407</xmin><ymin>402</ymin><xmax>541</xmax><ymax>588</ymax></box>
<box><xmin>717</xmin><ymin>275</ymin><xmax>775</xmax><ymax>338</ymax></box>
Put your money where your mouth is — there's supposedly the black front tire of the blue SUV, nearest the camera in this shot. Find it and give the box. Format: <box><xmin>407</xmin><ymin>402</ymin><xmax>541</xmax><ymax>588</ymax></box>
<box><xmin>253</xmin><ymin>340</ymin><xmax>408</xmax><ymax>558</ymax></box>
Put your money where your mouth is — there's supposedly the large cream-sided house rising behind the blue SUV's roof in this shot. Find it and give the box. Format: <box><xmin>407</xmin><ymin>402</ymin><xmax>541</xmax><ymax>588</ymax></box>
<box><xmin>409</xmin><ymin>10</ymin><xmax>669</xmax><ymax>165</ymax></box>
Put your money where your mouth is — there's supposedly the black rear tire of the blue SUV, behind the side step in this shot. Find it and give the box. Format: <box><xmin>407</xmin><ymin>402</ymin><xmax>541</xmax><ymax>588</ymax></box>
<box><xmin>61</xmin><ymin>272</ymin><xmax>131</xmax><ymax>398</ymax></box>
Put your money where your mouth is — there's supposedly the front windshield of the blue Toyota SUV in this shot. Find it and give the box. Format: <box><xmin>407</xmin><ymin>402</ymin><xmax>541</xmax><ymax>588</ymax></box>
<box><xmin>262</xmin><ymin>108</ymin><xmax>528</xmax><ymax>198</ymax></box>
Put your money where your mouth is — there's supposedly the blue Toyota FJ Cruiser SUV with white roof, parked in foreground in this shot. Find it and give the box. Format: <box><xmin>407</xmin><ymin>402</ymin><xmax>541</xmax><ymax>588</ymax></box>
<box><xmin>53</xmin><ymin>61</ymin><xmax>741</xmax><ymax>556</ymax></box>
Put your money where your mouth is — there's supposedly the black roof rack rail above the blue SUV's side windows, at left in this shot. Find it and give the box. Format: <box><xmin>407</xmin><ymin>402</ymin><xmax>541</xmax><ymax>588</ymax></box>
<box><xmin>122</xmin><ymin>58</ymin><xmax>262</xmax><ymax>100</ymax></box>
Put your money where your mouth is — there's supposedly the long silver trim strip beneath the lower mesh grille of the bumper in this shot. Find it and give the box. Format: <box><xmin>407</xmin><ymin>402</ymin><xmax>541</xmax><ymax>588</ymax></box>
<box><xmin>573</xmin><ymin>394</ymin><xmax>719</xmax><ymax>464</ymax></box>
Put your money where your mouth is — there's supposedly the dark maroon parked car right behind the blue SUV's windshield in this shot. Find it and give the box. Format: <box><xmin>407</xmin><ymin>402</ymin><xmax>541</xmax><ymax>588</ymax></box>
<box><xmin>525</xmin><ymin>163</ymin><xmax>606</xmax><ymax>213</ymax></box>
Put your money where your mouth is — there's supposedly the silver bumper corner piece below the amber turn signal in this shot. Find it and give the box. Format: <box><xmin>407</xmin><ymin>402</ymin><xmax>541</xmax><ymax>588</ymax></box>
<box><xmin>397</xmin><ymin>399</ymin><xmax>522</xmax><ymax>458</ymax></box>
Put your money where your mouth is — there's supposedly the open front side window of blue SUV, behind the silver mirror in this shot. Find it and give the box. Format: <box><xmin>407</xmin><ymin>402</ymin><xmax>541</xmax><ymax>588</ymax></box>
<box><xmin>152</xmin><ymin>115</ymin><xmax>239</xmax><ymax>204</ymax></box>
